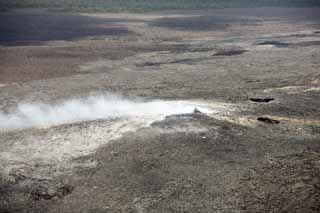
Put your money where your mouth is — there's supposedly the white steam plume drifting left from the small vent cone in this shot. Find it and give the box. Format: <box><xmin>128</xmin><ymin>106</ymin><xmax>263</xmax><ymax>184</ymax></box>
<box><xmin>0</xmin><ymin>95</ymin><xmax>212</xmax><ymax>130</ymax></box>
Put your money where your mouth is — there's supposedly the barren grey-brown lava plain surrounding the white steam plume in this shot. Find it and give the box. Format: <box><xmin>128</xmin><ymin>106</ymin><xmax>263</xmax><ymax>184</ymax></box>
<box><xmin>0</xmin><ymin>8</ymin><xmax>320</xmax><ymax>212</ymax></box>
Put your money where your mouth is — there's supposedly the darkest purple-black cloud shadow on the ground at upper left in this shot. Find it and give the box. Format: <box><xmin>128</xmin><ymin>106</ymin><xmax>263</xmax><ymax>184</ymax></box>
<box><xmin>0</xmin><ymin>12</ymin><xmax>129</xmax><ymax>46</ymax></box>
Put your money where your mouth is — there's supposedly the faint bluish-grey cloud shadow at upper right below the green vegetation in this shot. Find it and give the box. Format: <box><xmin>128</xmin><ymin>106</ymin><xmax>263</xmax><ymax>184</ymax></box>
<box><xmin>150</xmin><ymin>7</ymin><xmax>320</xmax><ymax>31</ymax></box>
